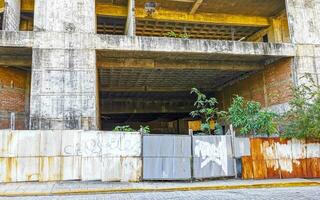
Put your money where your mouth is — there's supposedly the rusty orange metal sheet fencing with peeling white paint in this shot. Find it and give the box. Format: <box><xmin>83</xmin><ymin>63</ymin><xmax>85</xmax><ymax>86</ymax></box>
<box><xmin>242</xmin><ymin>138</ymin><xmax>320</xmax><ymax>179</ymax></box>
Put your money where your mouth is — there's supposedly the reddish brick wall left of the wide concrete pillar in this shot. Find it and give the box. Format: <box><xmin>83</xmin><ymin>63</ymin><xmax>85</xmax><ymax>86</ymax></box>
<box><xmin>0</xmin><ymin>67</ymin><xmax>30</xmax><ymax>129</ymax></box>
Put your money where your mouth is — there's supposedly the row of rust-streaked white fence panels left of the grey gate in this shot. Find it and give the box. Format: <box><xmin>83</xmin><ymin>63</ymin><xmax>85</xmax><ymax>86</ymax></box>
<box><xmin>0</xmin><ymin>130</ymin><xmax>142</xmax><ymax>182</ymax></box>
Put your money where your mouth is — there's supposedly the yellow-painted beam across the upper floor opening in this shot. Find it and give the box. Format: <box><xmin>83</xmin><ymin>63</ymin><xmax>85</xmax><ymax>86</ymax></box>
<box><xmin>96</xmin><ymin>4</ymin><xmax>270</xmax><ymax>27</ymax></box>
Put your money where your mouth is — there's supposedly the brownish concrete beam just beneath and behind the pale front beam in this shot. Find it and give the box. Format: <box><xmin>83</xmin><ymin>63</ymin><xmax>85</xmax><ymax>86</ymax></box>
<box><xmin>97</xmin><ymin>57</ymin><xmax>263</xmax><ymax>72</ymax></box>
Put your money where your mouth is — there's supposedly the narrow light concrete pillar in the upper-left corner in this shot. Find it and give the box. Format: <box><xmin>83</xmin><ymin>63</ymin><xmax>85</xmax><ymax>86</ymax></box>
<box><xmin>2</xmin><ymin>0</ymin><xmax>21</xmax><ymax>31</ymax></box>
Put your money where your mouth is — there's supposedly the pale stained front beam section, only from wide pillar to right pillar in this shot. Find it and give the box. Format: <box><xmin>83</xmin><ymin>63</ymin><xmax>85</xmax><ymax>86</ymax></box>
<box><xmin>96</xmin><ymin>35</ymin><xmax>295</xmax><ymax>59</ymax></box>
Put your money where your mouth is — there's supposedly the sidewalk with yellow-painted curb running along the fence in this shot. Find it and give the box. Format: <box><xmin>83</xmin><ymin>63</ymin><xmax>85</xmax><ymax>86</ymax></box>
<box><xmin>0</xmin><ymin>179</ymin><xmax>320</xmax><ymax>196</ymax></box>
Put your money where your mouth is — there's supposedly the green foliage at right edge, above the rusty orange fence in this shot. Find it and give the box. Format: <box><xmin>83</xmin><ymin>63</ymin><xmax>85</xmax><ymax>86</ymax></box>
<box><xmin>282</xmin><ymin>74</ymin><xmax>320</xmax><ymax>139</ymax></box>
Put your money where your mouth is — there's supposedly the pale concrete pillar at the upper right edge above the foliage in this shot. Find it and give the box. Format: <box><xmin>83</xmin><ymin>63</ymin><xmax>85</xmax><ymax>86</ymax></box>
<box><xmin>286</xmin><ymin>0</ymin><xmax>320</xmax><ymax>84</ymax></box>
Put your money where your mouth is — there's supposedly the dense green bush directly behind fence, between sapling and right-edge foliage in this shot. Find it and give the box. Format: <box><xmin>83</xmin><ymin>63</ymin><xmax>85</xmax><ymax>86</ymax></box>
<box><xmin>225</xmin><ymin>96</ymin><xmax>278</xmax><ymax>135</ymax></box>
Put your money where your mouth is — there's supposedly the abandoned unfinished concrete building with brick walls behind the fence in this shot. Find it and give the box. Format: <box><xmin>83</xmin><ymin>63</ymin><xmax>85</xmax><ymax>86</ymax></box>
<box><xmin>0</xmin><ymin>0</ymin><xmax>320</xmax><ymax>134</ymax></box>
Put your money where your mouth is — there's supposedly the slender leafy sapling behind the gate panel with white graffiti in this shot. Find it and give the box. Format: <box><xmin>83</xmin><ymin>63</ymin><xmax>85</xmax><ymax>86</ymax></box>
<box><xmin>190</xmin><ymin>88</ymin><xmax>219</xmax><ymax>134</ymax></box>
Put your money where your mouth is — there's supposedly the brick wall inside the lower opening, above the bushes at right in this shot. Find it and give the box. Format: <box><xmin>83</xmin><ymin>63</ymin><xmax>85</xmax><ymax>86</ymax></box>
<box><xmin>217</xmin><ymin>58</ymin><xmax>293</xmax><ymax>109</ymax></box>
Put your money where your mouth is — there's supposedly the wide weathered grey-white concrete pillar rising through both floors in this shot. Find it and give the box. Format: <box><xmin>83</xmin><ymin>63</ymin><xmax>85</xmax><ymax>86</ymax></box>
<box><xmin>30</xmin><ymin>0</ymin><xmax>98</xmax><ymax>130</ymax></box>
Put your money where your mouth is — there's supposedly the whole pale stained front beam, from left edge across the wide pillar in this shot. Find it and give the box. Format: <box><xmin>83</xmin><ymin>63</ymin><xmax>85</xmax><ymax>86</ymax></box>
<box><xmin>0</xmin><ymin>31</ymin><xmax>296</xmax><ymax>60</ymax></box>
